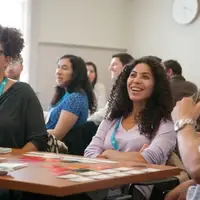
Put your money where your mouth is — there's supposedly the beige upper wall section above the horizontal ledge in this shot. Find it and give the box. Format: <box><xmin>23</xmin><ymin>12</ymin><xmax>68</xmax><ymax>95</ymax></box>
<box><xmin>39</xmin><ymin>0</ymin><xmax>129</xmax><ymax>48</ymax></box>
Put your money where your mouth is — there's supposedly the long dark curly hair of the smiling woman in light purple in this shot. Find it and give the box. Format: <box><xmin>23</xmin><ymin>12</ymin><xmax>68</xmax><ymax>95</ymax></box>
<box><xmin>106</xmin><ymin>56</ymin><xmax>173</xmax><ymax>139</ymax></box>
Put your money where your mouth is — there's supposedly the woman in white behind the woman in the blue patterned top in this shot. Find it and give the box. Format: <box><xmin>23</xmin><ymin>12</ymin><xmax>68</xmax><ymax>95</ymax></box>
<box><xmin>86</xmin><ymin>62</ymin><xmax>106</xmax><ymax>110</ymax></box>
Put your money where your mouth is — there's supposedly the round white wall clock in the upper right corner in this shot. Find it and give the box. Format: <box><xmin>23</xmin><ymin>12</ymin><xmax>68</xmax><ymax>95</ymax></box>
<box><xmin>173</xmin><ymin>0</ymin><xmax>199</xmax><ymax>24</ymax></box>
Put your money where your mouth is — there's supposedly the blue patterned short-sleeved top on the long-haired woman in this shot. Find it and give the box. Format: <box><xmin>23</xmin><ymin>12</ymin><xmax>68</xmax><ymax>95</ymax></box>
<box><xmin>46</xmin><ymin>92</ymin><xmax>88</xmax><ymax>129</ymax></box>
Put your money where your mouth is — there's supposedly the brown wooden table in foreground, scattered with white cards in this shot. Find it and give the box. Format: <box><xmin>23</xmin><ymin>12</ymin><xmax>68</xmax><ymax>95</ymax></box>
<box><xmin>0</xmin><ymin>152</ymin><xmax>180</xmax><ymax>196</ymax></box>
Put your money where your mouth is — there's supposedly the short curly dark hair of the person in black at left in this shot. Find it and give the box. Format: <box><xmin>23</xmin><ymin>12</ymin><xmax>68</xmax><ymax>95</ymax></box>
<box><xmin>0</xmin><ymin>25</ymin><xmax>24</xmax><ymax>61</ymax></box>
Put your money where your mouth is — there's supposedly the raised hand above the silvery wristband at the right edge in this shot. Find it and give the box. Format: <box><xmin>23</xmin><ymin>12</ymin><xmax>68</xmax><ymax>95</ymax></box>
<box><xmin>172</xmin><ymin>97</ymin><xmax>200</xmax><ymax>123</ymax></box>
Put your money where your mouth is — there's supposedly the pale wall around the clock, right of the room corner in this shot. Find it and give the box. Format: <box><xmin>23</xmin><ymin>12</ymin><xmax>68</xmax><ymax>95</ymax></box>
<box><xmin>129</xmin><ymin>0</ymin><xmax>200</xmax><ymax>87</ymax></box>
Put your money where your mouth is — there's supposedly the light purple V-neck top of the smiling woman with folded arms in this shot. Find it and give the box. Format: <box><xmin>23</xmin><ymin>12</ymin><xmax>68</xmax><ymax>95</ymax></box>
<box><xmin>84</xmin><ymin>120</ymin><xmax>176</xmax><ymax>199</ymax></box>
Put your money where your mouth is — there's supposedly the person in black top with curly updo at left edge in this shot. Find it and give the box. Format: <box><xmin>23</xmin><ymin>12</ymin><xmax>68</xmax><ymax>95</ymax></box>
<box><xmin>0</xmin><ymin>26</ymin><xmax>48</xmax><ymax>151</ymax></box>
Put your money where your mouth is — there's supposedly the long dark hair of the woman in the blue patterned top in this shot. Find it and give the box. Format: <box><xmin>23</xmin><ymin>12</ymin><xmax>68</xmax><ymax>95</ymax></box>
<box><xmin>51</xmin><ymin>55</ymin><xmax>97</xmax><ymax>113</ymax></box>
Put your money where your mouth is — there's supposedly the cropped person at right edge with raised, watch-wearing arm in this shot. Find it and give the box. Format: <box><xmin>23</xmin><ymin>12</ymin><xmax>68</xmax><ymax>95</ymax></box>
<box><xmin>165</xmin><ymin>98</ymin><xmax>200</xmax><ymax>200</ymax></box>
